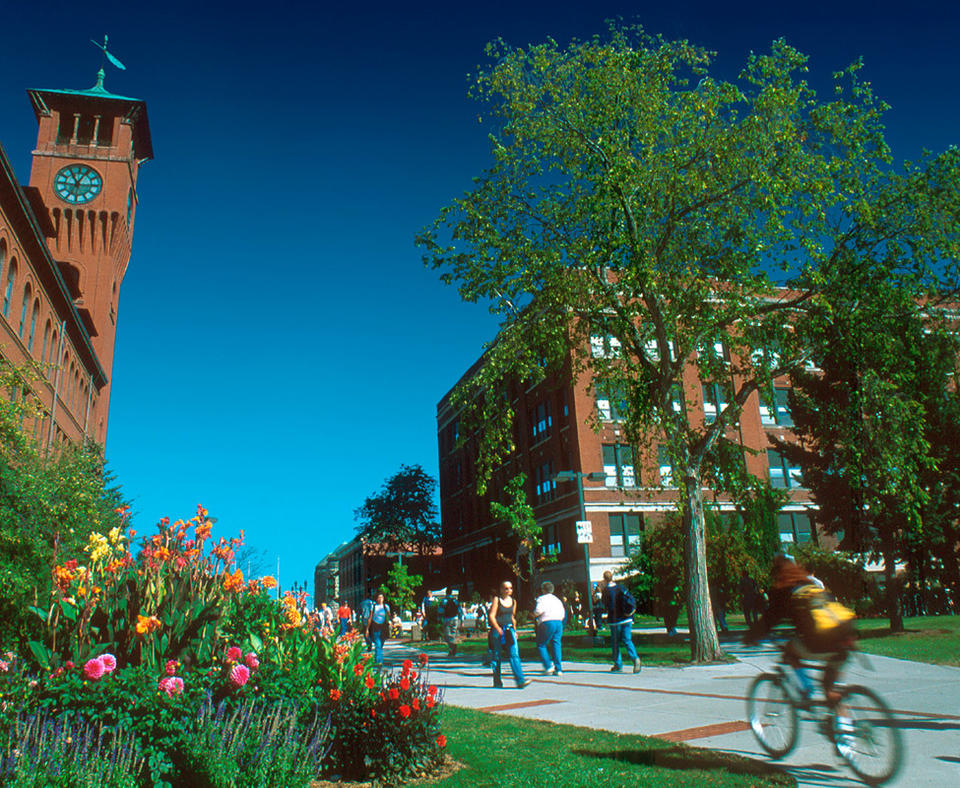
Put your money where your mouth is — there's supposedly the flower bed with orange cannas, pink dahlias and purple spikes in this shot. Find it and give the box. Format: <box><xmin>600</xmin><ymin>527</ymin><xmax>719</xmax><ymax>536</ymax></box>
<box><xmin>0</xmin><ymin>508</ymin><xmax>446</xmax><ymax>786</ymax></box>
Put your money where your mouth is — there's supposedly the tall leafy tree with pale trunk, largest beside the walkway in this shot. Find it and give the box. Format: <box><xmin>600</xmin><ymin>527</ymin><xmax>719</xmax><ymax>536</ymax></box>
<box><xmin>418</xmin><ymin>26</ymin><xmax>958</xmax><ymax>660</ymax></box>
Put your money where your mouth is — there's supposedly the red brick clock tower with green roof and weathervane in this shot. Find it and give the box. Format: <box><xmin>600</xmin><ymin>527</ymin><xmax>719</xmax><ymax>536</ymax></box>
<box><xmin>28</xmin><ymin>69</ymin><xmax>153</xmax><ymax>443</ymax></box>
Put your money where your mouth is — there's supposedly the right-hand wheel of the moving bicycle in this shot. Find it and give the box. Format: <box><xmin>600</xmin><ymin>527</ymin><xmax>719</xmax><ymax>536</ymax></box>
<box><xmin>833</xmin><ymin>686</ymin><xmax>903</xmax><ymax>785</ymax></box>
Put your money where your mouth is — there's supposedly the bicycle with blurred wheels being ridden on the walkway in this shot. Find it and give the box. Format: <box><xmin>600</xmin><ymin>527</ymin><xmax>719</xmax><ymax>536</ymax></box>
<box><xmin>747</xmin><ymin>644</ymin><xmax>903</xmax><ymax>785</ymax></box>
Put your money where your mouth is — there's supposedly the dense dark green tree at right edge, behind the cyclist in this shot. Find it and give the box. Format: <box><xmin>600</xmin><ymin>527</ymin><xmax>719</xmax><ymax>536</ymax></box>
<box><xmin>783</xmin><ymin>278</ymin><xmax>960</xmax><ymax>631</ymax></box>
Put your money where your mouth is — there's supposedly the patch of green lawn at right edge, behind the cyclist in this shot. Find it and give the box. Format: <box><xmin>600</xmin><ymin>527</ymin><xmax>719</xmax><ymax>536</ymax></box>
<box><xmin>857</xmin><ymin>616</ymin><xmax>960</xmax><ymax>665</ymax></box>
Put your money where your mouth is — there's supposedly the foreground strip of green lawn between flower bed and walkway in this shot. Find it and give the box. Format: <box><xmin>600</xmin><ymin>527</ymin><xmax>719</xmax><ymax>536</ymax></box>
<box><xmin>431</xmin><ymin>706</ymin><xmax>796</xmax><ymax>788</ymax></box>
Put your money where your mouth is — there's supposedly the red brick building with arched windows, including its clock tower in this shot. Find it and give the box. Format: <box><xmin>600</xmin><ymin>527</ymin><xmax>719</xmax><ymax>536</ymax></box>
<box><xmin>0</xmin><ymin>70</ymin><xmax>153</xmax><ymax>446</ymax></box>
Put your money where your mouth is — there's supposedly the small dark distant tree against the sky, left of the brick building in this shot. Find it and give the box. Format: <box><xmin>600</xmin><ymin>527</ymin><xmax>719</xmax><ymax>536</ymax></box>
<box><xmin>355</xmin><ymin>465</ymin><xmax>440</xmax><ymax>555</ymax></box>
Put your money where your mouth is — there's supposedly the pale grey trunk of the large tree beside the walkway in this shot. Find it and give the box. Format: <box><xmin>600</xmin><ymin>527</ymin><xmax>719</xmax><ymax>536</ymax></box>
<box><xmin>683</xmin><ymin>471</ymin><xmax>723</xmax><ymax>662</ymax></box>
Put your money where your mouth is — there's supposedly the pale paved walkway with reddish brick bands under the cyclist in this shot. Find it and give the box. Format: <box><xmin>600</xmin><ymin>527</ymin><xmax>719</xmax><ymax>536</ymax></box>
<box><xmin>387</xmin><ymin>642</ymin><xmax>960</xmax><ymax>788</ymax></box>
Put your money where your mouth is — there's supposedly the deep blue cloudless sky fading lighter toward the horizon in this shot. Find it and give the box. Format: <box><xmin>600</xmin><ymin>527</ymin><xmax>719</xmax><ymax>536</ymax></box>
<box><xmin>0</xmin><ymin>0</ymin><xmax>960</xmax><ymax>585</ymax></box>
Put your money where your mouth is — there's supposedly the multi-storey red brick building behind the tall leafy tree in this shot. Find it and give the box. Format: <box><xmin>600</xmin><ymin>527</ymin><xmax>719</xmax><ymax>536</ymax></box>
<box><xmin>437</xmin><ymin>330</ymin><xmax>816</xmax><ymax>604</ymax></box>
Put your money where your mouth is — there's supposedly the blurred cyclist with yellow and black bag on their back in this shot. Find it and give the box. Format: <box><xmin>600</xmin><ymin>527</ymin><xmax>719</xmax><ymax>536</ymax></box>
<box><xmin>744</xmin><ymin>554</ymin><xmax>857</xmax><ymax>704</ymax></box>
